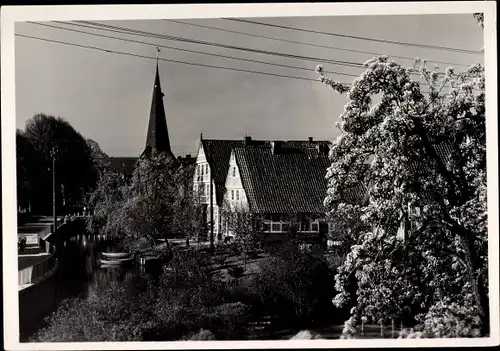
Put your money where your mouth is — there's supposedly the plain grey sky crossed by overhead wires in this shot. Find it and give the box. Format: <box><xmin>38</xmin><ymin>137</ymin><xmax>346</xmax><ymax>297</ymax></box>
<box><xmin>15</xmin><ymin>14</ymin><xmax>483</xmax><ymax>157</ymax></box>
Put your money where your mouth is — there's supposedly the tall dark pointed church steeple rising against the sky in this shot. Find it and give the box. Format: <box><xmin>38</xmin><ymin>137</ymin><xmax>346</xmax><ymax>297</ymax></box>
<box><xmin>143</xmin><ymin>57</ymin><xmax>175</xmax><ymax>158</ymax></box>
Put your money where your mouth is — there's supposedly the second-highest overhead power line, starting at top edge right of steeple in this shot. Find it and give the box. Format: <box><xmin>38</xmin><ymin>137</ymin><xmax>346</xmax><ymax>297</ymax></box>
<box><xmin>164</xmin><ymin>19</ymin><xmax>469</xmax><ymax>67</ymax></box>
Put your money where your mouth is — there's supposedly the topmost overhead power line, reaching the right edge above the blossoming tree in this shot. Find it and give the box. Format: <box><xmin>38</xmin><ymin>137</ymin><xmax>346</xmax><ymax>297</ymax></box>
<box><xmin>224</xmin><ymin>18</ymin><xmax>483</xmax><ymax>54</ymax></box>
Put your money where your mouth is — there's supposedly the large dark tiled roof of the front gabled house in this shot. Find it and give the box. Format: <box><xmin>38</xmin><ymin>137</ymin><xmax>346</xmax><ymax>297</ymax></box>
<box><xmin>234</xmin><ymin>141</ymin><xmax>331</xmax><ymax>213</ymax></box>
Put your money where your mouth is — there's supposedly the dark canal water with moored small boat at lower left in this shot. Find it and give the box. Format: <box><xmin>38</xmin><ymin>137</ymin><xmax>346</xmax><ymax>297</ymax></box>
<box><xmin>20</xmin><ymin>220</ymin><xmax>160</xmax><ymax>342</ymax></box>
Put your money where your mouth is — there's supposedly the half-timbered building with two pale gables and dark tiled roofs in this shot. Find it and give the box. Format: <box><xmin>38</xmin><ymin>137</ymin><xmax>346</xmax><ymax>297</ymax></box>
<box><xmin>194</xmin><ymin>136</ymin><xmax>331</xmax><ymax>245</ymax></box>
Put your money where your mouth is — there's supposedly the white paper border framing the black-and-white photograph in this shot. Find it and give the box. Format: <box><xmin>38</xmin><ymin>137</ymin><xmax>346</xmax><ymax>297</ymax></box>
<box><xmin>1</xmin><ymin>1</ymin><xmax>500</xmax><ymax>350</ymax></box>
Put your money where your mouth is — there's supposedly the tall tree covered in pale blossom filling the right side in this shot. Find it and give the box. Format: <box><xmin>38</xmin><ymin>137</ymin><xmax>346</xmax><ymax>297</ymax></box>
<box><xmin>318</xmin><ymin>57</ymin><xmax>489</xmax><ymax>334</ymax></box>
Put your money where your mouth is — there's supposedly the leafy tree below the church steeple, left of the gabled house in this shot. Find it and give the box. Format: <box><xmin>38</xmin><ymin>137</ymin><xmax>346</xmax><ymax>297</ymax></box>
<box><xmin>88</xmin><ymin>150</ymin><xmax>203</xmax><ymax>246</ymax></box>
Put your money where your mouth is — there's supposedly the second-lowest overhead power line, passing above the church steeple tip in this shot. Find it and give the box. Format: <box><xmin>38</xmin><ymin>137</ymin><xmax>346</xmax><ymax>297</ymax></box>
<box><xmin>27</xmin><ymin>21</ymin><xmax>359</xmax><ymax>77</ymax></box>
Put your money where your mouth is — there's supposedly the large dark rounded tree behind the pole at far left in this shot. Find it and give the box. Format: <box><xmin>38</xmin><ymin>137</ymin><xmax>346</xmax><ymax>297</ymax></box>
<box><xmin>17</xmin><ymin>114</ymin><xmax>97</xmax><ymax>212</ymax></box>
